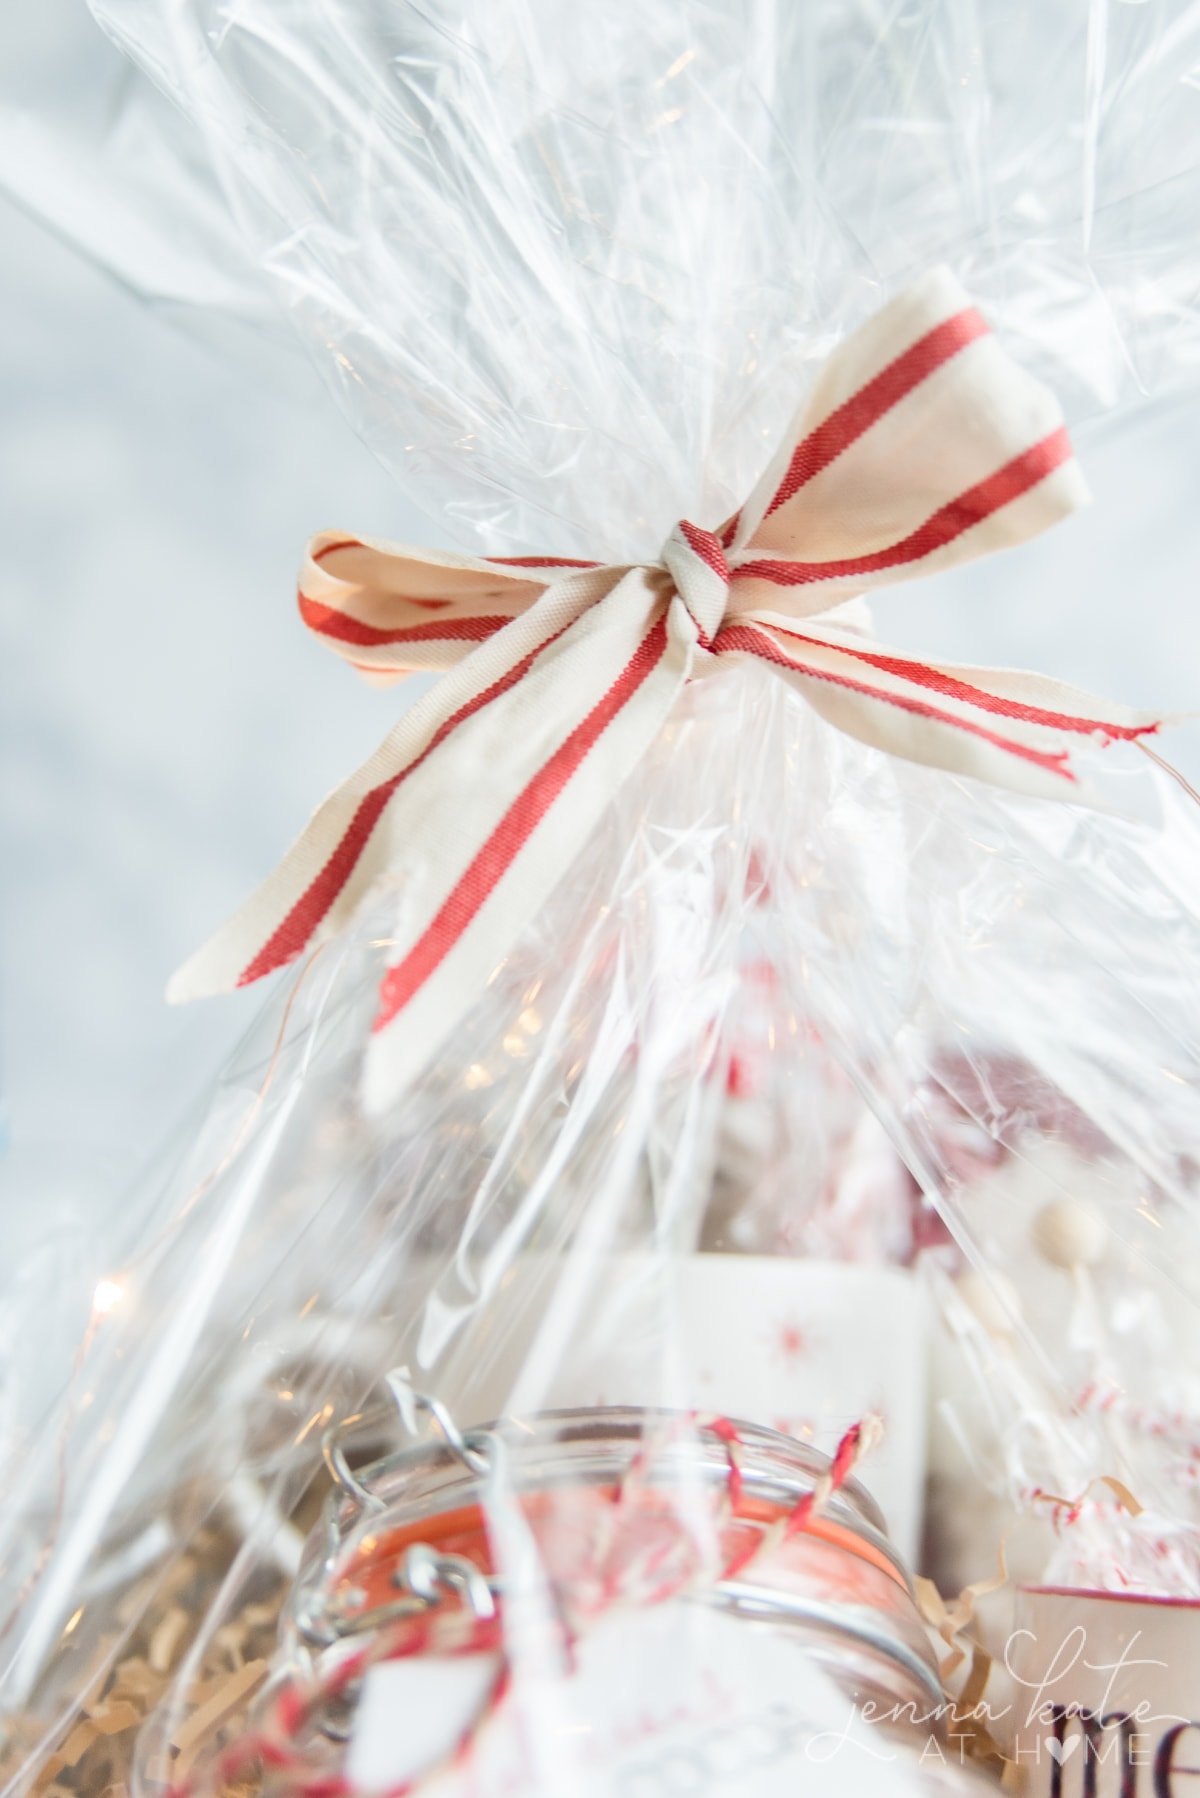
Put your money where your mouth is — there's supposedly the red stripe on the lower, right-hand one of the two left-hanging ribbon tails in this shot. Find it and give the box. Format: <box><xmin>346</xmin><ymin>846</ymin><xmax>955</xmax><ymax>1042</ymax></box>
<box><xmin>372</xmin><ymin>619</ymin><xmax>667</xmax><ymax>1030</ymax></box>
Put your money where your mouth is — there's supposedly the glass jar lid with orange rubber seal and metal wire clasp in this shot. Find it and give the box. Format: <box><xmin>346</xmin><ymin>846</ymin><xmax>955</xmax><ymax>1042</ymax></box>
<box><xmin>286</xmin><ymin>1401</ymin><xmax>943</xmax><ymax>1713</ymax></box>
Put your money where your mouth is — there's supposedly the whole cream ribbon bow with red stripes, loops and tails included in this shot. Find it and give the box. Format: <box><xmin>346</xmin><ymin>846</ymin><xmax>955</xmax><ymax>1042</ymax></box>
<box><xmin>169</xmin><ymin>270</ymin><xmax>1157</xmax><ymax>1106</ymax></box>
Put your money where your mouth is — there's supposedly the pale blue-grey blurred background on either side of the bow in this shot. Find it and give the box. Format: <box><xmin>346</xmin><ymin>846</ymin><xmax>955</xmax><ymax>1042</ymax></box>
<box><xmin>0</xmin><ymin>0</ymin><xmax>1200</xmax><ymax>1262</ymax></box>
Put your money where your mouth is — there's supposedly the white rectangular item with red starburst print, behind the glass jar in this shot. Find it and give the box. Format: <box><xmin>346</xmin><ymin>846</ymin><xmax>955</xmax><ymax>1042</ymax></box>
<box><xmin>431</xmin><ymin>1253</ymin><xmax>928</xmax><ymax>1561</ymax></box>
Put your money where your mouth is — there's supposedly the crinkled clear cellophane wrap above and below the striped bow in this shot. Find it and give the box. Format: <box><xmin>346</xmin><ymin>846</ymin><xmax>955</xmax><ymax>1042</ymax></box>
<box><xmin>0</xmin><ymin>0</ymin><xmax>1200</xmax><ymax>1789</ymax></box>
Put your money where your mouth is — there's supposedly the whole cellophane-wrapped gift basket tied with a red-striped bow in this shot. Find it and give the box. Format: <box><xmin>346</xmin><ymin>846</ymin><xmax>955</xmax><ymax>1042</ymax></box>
<box><xmin>0</xmin><ymin>0</ymin><xmax>1200</xmax><ymax>1798</ymax></box>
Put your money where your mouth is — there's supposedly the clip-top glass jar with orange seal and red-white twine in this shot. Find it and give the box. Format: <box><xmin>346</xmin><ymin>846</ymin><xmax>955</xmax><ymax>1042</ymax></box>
<box><xmin>251</xmin><ymin>1401</ymin><xmax>943</xmax><ymax>1794</ymax></box>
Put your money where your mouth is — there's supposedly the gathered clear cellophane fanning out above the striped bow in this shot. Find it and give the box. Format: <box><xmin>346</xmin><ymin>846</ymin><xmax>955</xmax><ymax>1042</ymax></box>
<box><xmin>5</xmin><ymin>0</ymin><xmax>1200</xmax><ymax>542</ymax></box>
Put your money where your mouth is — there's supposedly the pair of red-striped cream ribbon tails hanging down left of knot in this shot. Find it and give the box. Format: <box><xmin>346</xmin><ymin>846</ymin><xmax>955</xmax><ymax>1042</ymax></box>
<box><xmin>169</xmin><ymin>568</ymin><xmax>696</xmax><ymax>1109</ymax></box>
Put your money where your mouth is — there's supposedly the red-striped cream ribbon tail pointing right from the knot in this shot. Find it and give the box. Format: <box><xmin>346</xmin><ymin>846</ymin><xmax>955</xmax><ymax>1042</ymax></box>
<box><xmin>714</xmin><ymin>613</ymin><xmax>1164</xmax><ymax>804</ymax></box>
